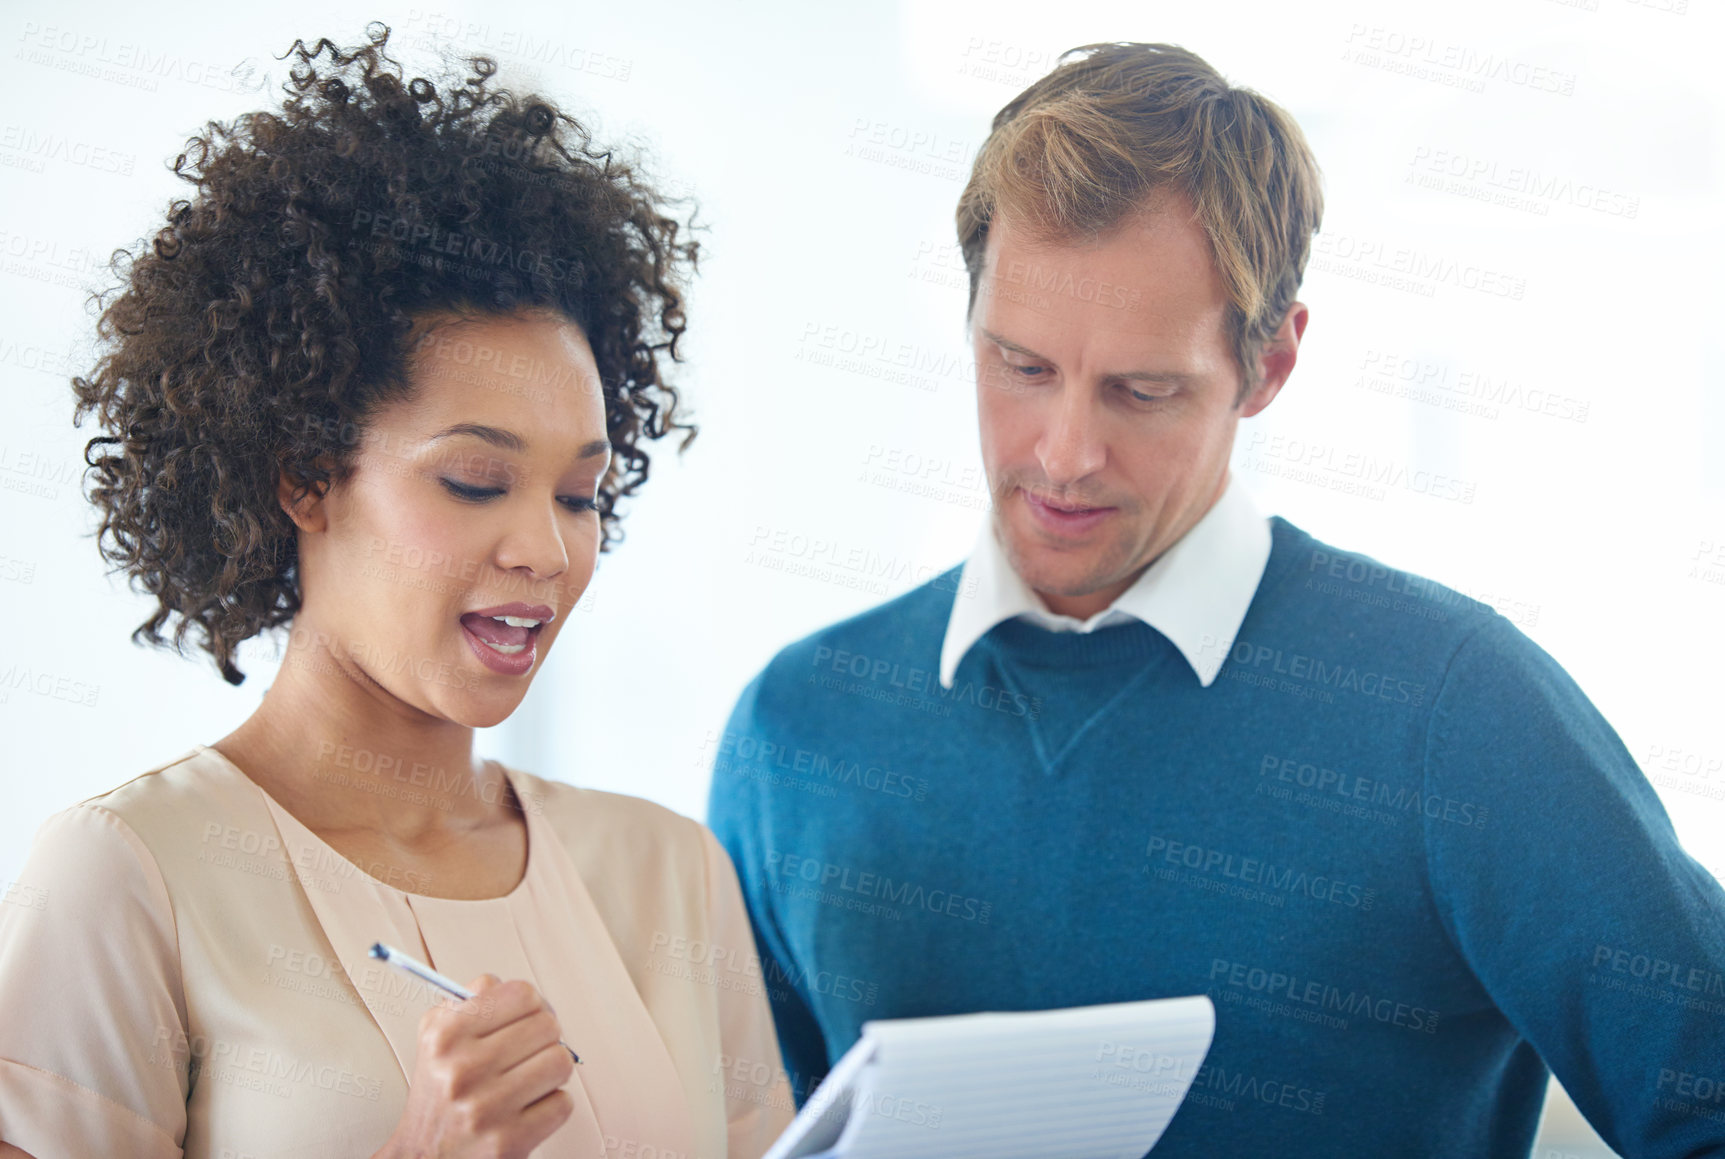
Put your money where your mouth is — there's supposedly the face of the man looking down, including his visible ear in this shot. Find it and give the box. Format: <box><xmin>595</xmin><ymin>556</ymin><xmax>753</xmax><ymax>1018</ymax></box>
<box><xmin>971</xmin><ymin>193</ymin><xmax>1306</xmax><ymax>617</ymax></box>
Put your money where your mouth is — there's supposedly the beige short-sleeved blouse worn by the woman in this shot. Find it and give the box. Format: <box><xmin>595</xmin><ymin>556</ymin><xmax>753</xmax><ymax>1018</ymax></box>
<box><xmin>0</xmin><ymin>745</ymin><xmax>794</xmax><ymax>1159</ymax></box>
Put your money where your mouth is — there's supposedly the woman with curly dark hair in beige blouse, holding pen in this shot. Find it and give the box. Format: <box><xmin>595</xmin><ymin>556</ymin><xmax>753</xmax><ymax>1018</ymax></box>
<box><xmin>0</xmin><ymin>26</ymin><xmax>792</xmax><ymax>1159</ymax></box>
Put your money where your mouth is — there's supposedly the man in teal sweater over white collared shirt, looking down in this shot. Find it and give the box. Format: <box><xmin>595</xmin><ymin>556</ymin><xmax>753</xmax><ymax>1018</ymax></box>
<box><xmin>709</xmin><ymin>45</ymin><xmax>1725</xmax><ymax>1156</ymax></box>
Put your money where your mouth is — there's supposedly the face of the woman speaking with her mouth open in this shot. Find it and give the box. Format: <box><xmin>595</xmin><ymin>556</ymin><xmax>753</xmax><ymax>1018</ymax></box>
<box><xmin>293</xmin><ymin>312</ymin><xmax>611</xmax><ymax>728</ymax></box>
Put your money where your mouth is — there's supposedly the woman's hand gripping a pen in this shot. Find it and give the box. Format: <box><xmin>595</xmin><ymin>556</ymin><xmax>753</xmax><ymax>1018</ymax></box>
<box><xmin>374</xmin><ymin>974</ymin><xmax>574</xmax><ymax>1159</ymax></box>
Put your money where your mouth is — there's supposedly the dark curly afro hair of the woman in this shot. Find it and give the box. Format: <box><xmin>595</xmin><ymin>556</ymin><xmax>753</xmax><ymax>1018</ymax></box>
<box><xmin>72</xmin><ymin>24</ymin><xmax>697</xmax><ymax>685</ymax></box>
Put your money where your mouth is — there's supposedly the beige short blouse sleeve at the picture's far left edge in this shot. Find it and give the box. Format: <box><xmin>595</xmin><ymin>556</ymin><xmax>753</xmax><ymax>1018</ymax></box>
<box><xmin>0</xmin><ymin>804</ymin><xmax>190</xmax><ymax>1159</ymax></box>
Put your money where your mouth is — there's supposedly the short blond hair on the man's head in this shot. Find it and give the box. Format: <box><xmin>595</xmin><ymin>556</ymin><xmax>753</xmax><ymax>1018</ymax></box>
<box><xmin>957</xmin><ymin>43</ymin><xmax>1323</xmax><ymax>400</ymax></box>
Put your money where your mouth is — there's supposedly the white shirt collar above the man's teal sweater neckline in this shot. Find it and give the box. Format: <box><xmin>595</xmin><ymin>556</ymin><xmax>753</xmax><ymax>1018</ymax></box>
<box><xmin>940</xmin><ymin>473</ymin><xmax>1270</xmax><ymax>688</ymax></box>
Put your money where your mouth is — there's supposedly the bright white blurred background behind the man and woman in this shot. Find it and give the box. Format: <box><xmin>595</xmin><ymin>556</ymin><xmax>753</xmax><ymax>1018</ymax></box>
<box><xmin>0</xmin><ymin>0</ymin><xmax>1725</xmax><ymax>1156</ymax></box>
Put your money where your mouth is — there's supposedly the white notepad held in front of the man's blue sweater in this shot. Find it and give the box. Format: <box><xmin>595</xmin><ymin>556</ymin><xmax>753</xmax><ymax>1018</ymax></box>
<box><xmin>766</xmin><ymin>995</ymin><xmax>1216</xmax><ymax>1159</ymax></box>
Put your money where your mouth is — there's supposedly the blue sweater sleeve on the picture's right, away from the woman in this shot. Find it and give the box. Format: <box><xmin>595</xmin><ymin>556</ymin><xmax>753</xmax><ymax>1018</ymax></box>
<box><xmin>1423</xmin><ymin>616</ymin><xmax>1725</xmax><ymax>1159</ymax></box>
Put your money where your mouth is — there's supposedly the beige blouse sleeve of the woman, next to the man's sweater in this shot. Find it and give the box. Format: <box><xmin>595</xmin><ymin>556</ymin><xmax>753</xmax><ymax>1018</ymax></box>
<box><xmin>700</xmin><ymin>826</ymin><xmax>795</xmax><ymax>1159</ymax></box>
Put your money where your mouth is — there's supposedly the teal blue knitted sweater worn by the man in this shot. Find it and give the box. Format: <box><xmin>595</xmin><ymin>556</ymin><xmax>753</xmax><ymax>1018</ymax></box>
<box><xmin>709</xmin><ymin>517</ymin><xmax>1725</xmax><ymax>1159</ymax></box>
